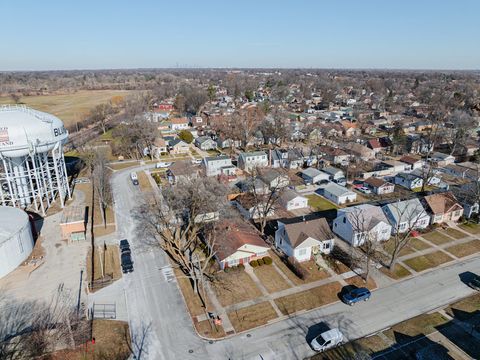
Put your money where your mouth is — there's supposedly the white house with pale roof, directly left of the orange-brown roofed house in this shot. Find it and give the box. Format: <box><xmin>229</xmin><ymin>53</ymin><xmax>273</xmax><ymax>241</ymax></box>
<box><xmin>382</xmin><ymin>198</ymin><xmax>430</xmax><ymax>233</ymax></box>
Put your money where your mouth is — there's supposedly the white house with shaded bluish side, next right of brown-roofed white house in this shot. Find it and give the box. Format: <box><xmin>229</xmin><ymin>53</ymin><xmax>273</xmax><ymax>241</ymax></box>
<box><xmin>332</xmin><ymin>204</ymin><xmax>392</xmax><ymax>246</ymax></box>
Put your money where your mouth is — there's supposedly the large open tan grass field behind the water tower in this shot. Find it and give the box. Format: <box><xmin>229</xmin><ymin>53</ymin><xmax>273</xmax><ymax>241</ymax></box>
<box><xmin>0</xmin><ymin>90</ymin><xmax>134</xmax><ymax>126</ymax></box>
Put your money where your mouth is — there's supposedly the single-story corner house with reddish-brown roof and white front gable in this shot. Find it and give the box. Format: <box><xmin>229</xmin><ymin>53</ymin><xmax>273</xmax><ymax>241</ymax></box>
<box><xmin>214</xmin><ymin>221</ymin><xmax>270</xmax><ymax>269</ymax></box>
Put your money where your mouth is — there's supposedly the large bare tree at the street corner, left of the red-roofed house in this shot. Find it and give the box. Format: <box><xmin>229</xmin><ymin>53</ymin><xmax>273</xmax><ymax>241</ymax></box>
<box><xmin>136</xmin><ymin>177</ymin><xmax>228</xmax><ymax>306</ymax></box>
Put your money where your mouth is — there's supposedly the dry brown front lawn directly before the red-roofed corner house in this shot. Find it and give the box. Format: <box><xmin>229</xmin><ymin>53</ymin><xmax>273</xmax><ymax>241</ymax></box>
<box><xmin>212</xmin><ymin>271</ymin><xmax>262</xmax><ymax>306</ymax></box>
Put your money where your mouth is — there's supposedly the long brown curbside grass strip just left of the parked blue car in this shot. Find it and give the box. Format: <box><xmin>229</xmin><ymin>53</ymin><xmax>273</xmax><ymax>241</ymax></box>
<box><xmin>275</xmin><ymin>281</ymin><xmax>342</xmax><ymax>315</ymax></box>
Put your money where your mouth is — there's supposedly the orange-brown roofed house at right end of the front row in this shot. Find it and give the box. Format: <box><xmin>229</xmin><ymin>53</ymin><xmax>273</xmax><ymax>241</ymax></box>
<box><xmin>423</xmin><ymin>191</ymin><xmax>463</xmax><ymax>224</ymax></box>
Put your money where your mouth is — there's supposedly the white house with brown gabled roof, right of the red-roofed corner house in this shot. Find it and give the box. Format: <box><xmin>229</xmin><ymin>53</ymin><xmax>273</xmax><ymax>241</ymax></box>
<box><xmin>275</xmin><ymin>218</ymin><xmax>335</xmax><ymax>261</ymax></box>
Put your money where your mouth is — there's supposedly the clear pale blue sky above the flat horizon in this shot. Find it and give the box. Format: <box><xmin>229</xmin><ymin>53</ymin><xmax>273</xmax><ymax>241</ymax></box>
<box><xmin>0</xmin><ymin>0</ymin><xmax>480</xmax><ymax>70</ymax></box>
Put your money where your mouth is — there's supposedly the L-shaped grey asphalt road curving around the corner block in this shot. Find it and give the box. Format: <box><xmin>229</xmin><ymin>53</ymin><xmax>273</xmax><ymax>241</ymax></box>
<box><xmin>112</xmin><ymin>168</ymin><xmax>480</xmax><ymax>360</ymax></box>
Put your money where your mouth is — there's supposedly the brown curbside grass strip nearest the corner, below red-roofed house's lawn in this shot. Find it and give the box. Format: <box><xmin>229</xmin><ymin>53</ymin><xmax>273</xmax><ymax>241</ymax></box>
<box><xmin>227</xmin><ymin>301</ymin><xmax>277</xmax><ymax>332</ymax></box>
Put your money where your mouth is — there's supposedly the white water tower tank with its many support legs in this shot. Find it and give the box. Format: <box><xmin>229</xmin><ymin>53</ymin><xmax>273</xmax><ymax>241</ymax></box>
<box><xmin>0</xmin><ymin>105</ymin><xmax>71</xmax><ymax>214</ymax></box>
